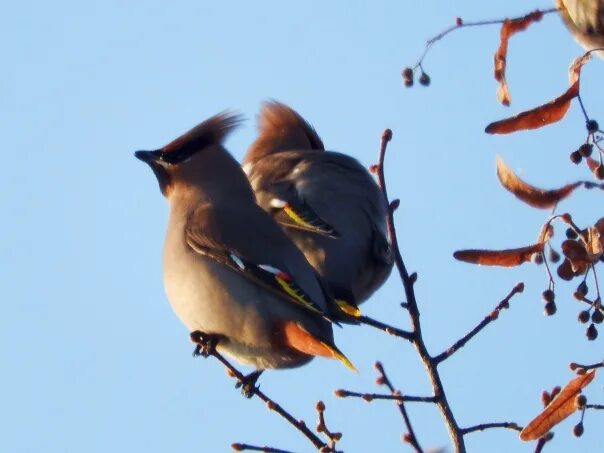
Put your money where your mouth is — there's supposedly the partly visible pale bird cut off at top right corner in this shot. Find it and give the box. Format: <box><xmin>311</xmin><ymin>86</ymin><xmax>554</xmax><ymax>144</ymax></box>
<box><xmin>554</xmin><ymin>0</ymin><xmax>604</xmax><ymax>58</ymax></box>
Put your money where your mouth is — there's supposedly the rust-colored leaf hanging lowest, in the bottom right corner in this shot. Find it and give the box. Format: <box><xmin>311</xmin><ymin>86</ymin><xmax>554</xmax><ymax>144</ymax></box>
<box><xmin>520</xmin><ymin>370</ymin><xmax>596</xmax><ymax>441</ymax></box>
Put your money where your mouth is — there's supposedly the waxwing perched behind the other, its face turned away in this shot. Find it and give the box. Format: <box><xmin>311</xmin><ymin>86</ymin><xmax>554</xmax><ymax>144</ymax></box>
<box><xmin>242</xmin><ymin>100</ymin><xmax>394</xmax><ymax>318</ymax></box>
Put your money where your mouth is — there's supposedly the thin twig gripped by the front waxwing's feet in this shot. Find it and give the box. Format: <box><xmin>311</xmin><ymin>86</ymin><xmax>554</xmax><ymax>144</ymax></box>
<box><xmin>191</xmin><ymin>332</ymin><xmax>331</xmax><ymax>451</ymax></box>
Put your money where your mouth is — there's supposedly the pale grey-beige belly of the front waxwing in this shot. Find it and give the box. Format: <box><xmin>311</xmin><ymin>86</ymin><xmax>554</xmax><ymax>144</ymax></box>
<box><xmin>164</xmin><ymin>252</ymin><xmax>310</xmax><ymax>368</ymax></box>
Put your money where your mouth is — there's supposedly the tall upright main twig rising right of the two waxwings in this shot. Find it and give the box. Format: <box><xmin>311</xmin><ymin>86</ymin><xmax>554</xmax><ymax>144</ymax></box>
<box><xmin>376</xmin><ymin>129</ymin><xmax>466</xmax><ymax>453</ymax></box>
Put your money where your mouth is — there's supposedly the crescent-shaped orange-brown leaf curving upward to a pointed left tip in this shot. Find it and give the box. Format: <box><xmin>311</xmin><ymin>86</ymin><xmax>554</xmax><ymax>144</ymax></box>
<box><xmin>497</xmin><ymin>156</ymin><xmax>582</xmax><ymax>209</ymax></box>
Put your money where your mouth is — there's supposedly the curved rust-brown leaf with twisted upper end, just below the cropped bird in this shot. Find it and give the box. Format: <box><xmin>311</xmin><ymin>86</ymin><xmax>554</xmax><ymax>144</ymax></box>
<box><xmin>485</xmin><ymin>54</ymin><xmax>590</xmax><ymax>134</ymax></box>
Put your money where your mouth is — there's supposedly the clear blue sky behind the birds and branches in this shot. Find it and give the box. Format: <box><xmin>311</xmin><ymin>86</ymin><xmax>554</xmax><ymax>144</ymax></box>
<box><xmin>0</xmin><ymin>0</ymin><xmax>604</xmax><ymax>453</ymax></box>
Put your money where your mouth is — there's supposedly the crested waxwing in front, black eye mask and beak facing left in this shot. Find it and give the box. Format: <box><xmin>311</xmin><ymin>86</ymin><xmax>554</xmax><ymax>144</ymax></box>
<box><xmin>135</xmin><ymin>113</ymin><xmax>354</xmax><ymax>369</ymax></box>
